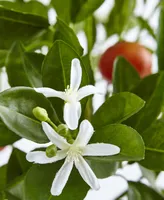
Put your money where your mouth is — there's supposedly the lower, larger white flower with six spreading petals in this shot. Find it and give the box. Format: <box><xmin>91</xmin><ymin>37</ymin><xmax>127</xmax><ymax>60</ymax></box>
<box><xmin>27</xmin><ymin>120</ymin><xmax>120</xmax><ymax>196</ymax></box>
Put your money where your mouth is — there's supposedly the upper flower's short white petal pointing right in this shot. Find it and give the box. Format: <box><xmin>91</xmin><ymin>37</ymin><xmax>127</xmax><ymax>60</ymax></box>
<box><xmin>77</xmin><ymin>85</ymin><xmax>97</xmax><ymax>101</ymax></box>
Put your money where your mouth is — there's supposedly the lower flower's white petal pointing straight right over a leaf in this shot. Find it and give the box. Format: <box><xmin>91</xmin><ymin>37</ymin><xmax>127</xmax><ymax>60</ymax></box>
<box><xmin>83</xmin><ymin>143</ymin><xmax>120</xmax><ymax>156</ymax></box>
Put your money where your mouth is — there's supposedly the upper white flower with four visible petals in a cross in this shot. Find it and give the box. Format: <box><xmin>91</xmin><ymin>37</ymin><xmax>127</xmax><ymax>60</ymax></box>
<box><xmin>35</xmin><ymin>58</ymin><xmax>96</xmax><ymax>130</ymax></box>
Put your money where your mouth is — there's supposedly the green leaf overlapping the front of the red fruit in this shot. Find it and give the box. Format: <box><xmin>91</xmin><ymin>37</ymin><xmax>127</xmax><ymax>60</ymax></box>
<box><xmin>113</xmin><ymin>57</ymin><xmax>140</xmax><ymax>93</ymax></box>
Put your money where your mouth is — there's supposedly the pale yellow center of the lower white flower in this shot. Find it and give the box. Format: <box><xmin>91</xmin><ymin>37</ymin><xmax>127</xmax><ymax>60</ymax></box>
<box><xmin>67</xmin><ymin>146</ymin><xmax>82</xmax><ymax>162</ymax></box>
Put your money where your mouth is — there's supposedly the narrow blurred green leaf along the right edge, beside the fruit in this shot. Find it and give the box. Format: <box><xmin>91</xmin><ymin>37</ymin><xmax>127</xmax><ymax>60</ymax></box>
<box><xmin>157</xmin><ymin>7</ymin><xmax>164</xmax><ymax>70</ymax></box>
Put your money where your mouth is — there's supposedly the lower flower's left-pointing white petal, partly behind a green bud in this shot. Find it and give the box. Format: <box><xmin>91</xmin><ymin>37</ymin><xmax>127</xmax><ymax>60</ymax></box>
<box><xmin>26</xmin><ymin>150</ymin><xmax>67</xmax><ymax>164</ymax></box>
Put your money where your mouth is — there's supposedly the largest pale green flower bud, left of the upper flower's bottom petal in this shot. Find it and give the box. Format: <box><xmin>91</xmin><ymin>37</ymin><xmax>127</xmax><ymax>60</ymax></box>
<box><xmin>32</xmin><ymin>107</ymin><xmax>49</xmax><ymax>122</ymax></box>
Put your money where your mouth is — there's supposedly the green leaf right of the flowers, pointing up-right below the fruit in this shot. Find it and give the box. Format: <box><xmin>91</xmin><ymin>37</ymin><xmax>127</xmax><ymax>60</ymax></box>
<box><xmin>92</xmin><ymin>92</ymin><xmax>144</xmax><ymax>129</ymax></box>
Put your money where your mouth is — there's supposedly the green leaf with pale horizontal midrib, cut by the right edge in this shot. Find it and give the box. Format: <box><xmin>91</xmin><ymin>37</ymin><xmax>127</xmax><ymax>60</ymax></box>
<box><xmin>140</xmin><ymin>120</ymin><xmax>164</xmax><ymax>171</ymax></box>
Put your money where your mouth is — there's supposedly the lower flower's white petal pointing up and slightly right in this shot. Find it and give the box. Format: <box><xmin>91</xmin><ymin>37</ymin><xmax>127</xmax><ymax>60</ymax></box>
<box><xmin>74</xmin><ymin>120</ymin><xmax>94</xmax><ymax>146</ymax></box>
